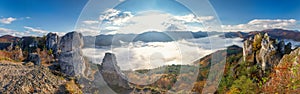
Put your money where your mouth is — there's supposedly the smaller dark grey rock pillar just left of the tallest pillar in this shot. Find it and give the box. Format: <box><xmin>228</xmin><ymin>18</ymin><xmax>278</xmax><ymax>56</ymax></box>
<box><xmin>46</xmin><ymin>33</ymin><xmax>59</xmax><ymax>56</ymax></box>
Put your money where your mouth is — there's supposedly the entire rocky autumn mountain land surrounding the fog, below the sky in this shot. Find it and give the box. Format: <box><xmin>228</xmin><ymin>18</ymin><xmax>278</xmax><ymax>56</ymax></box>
<box><xmin>0</xmin><ymin>29</ymin><xmax>300</xmax><ymax>94</ymax></box>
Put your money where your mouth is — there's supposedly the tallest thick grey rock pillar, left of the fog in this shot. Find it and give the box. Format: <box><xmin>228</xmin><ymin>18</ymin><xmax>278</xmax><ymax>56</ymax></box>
<box><xmin>58</xmin><ymin>32</ymin><xmax>86</xmax><ymax>76</ymax></box>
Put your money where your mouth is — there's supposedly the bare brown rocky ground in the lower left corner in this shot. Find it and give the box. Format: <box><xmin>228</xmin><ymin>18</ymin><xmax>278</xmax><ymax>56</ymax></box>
<box><xmin>0</xmin><ymin>61</ymin><xmax>67</xmax><ymax>94</ymax></box>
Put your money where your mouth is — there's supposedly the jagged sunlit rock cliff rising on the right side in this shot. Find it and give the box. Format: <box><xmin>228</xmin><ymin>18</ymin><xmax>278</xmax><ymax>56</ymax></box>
<box><xmin>243</xmin><ymin>33</ymin><xmax>291</xmax><ymax>72</ymax></box>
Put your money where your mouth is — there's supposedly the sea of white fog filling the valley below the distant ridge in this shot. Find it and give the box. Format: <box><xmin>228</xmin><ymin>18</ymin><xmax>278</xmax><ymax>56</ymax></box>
<box><xmin>83</xmin><ymin>35</ymin><xmax>242</xmax><ymax>70</ymax></box>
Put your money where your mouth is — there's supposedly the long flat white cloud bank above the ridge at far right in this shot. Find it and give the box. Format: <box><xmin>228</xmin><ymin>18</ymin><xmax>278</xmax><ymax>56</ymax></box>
<box><xmin>222</xmin><ymin>19</ymin><xmax>299</xmax><ymax>31</ymax></box>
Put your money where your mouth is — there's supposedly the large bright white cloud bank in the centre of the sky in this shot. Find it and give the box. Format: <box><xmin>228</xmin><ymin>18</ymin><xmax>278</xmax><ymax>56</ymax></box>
<box><xmin>99</xmin><ymin>9</ymin><xmax>214</xmax><ymax>34</ymax></box>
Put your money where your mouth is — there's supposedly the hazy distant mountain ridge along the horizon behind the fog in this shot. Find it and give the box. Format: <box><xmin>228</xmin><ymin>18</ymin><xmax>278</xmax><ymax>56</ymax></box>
<box><xmin>0</xmin><ymin>29</ymin><xmax>300</xmax><ymax>48</ymax></box>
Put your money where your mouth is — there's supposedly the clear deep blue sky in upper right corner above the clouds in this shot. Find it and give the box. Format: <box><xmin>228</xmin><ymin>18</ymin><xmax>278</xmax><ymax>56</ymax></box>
<box><xmin>210</xmin><ymin>0</ymin><xmax>300</xmax><ymax>24</ymax></box>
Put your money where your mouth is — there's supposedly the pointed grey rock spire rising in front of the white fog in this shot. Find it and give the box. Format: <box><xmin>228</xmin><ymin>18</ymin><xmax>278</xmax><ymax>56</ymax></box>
<box><xmin>99</xmin><ymin>53</ymin><xmax>129</xmax><ymax>89</ymax></box>
